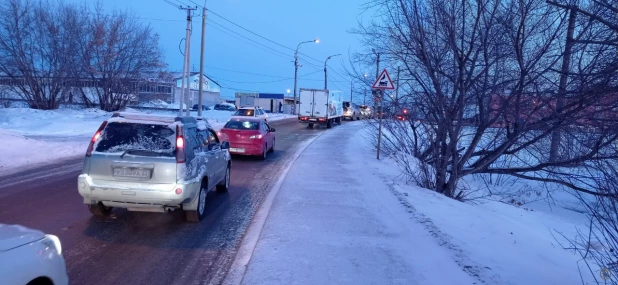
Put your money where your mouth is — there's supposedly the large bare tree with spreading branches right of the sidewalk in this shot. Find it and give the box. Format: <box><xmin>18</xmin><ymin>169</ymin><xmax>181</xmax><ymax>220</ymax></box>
<box><xmin>356</xmin><ymin>0</ymin><xmax>618</xmax><ymax>198</ymax></box>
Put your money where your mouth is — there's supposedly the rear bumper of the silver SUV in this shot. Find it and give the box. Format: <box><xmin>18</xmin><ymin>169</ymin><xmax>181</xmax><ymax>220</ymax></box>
<box><xmin>77</xmin><ymin>174</ymin><xmax>201</xmax><ymax>211</ymax></box>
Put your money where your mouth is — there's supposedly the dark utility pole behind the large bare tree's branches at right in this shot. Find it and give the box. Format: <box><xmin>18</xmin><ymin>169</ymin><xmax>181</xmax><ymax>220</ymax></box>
<box><xmin>549</xmin><ymin>7</ymin><xmax>577</xmax><ymax>162</ymax></box>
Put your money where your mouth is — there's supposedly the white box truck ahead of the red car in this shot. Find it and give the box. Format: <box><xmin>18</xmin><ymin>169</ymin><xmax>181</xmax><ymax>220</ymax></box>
<box><xmin>298</xmin><ymin>88</ymin><xmax>343</xmax><ymax>128</ymax></box>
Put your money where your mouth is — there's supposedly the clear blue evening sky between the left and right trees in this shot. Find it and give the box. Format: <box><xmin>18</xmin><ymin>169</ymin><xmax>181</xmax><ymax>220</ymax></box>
<box><xmin>74</xmin><ymin>0</ymin><xmax>365</xmax><ymax>97</ymax></box>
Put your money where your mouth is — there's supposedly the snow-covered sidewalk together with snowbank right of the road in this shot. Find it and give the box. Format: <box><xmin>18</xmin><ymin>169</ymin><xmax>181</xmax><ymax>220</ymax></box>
<box><xmin>233</xmin><ymin>122</ymin><xmax>596</xmax><ymax>285</ymax></box>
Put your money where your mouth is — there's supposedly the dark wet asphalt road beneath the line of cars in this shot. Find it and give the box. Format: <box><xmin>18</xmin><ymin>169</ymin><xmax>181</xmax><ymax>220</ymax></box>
<box><xmin>0</xmin><ymin>117</ymin><xmax>337</xmax><ymax>284</ymax></box>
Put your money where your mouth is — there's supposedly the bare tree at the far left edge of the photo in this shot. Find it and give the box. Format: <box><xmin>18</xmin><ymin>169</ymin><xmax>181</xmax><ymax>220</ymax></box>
<box><xmin>0</xmin><ymin>0</ymin><xmax>81</xmax><ymax>109</ymax></box>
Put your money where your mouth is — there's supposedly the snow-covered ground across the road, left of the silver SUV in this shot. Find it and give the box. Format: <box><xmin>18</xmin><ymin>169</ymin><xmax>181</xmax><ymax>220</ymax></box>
<box><xmin>0</xmin><ymin>108</ymin><xmax>290</xmax><ymax>175</ymax></box>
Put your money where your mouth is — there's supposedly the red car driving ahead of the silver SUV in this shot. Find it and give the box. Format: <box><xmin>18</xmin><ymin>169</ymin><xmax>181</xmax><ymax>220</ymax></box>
<box><xmin>219</xmin><ymin>117</ymin><xmax>275</xmax><ymax>159</ymax></box>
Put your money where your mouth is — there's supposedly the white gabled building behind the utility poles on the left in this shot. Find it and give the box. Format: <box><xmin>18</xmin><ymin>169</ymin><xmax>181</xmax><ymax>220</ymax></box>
<box><xmin>173</xmin><ymin>72</ymin><xmax>221</xmax><ymax>108</ymax></box>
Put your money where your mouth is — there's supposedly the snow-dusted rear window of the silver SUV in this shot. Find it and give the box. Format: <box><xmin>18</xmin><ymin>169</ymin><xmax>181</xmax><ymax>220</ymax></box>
<box><xmin>95</xmin><ymin>122</ymin><xmax>176</xmax><ymax>156</ymax></box>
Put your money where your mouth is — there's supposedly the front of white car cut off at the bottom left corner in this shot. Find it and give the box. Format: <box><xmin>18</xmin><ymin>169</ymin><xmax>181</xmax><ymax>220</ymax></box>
<box><xmin>0</xmin><ymin>224</ymin><xmax>69</xmax><ymax>285</ymax></box>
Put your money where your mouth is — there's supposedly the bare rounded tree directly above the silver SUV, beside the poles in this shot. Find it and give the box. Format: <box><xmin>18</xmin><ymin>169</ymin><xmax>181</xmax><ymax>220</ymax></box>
<box><xmin>79</xmin><ymin>5</ymin><xmax>164</xmax><ymax>111</ymax></box>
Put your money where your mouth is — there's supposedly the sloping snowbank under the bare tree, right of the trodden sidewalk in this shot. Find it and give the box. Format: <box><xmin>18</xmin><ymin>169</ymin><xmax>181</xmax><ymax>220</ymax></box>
<box><xmin>349</xmin><ymin>127</ymin><xmax>595</xmax><ymax>284</ymax></box>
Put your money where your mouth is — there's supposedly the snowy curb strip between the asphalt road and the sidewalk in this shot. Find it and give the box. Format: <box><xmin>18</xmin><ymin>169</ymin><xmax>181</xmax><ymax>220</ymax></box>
<box><xmin>223</xmin><ymin>128</ymin><xmax>326</xmax><ymax>285</ymax></box>
